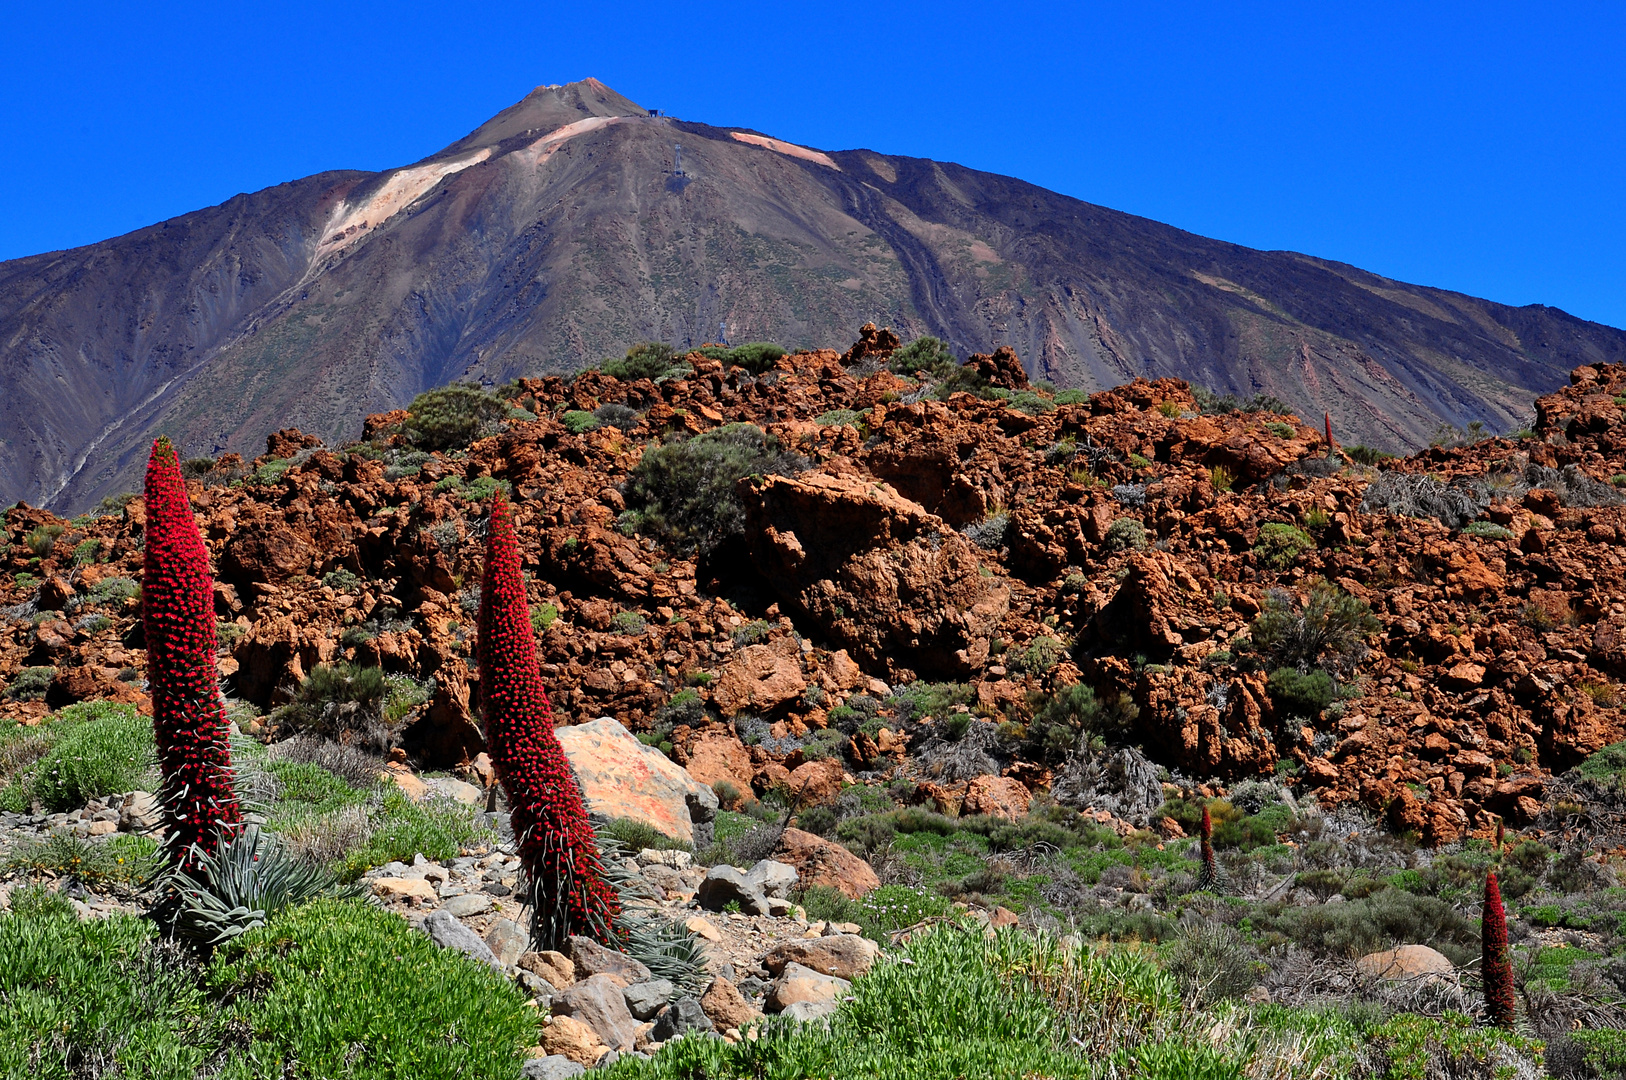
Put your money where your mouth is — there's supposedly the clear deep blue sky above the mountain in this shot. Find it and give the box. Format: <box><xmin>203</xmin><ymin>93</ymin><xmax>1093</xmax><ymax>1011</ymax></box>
<box><xmin>0</xmin><ymin>0</ymin><xmax>1626</xmax><ymax>327</ymax></box>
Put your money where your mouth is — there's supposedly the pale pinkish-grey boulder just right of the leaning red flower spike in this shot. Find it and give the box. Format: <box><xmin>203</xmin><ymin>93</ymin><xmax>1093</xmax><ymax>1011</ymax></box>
<box><xmin>554</xmin><ymin>716</ymin><xmax>717</xmax><ymax>844</ymax></box>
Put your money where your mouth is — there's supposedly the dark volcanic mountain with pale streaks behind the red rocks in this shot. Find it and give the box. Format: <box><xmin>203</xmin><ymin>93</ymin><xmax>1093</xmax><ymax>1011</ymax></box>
<box><xmin>0</xmin><ymin>80</ymin><xmax>1626</xmax><ymax>511</ymax></box>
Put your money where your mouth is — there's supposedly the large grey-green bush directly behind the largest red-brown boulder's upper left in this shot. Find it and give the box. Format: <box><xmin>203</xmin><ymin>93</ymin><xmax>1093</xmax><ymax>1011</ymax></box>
<box><xmin>626</xmin><ymin>423</ymin><xmax>808</xmax><ymax>555</ymax></box>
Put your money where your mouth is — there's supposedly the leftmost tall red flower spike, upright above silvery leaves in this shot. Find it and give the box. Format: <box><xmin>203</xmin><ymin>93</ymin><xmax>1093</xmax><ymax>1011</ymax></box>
<box><xmin>141</xmin><ymin>439</ymin><xmax>242</xmax><ymax>869</ymax></box>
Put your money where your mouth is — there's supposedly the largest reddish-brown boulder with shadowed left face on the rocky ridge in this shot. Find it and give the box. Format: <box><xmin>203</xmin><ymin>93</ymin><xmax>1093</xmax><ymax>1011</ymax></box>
<box><xmin>743</xmin><ymin>472</ymin><xmax>1010</xmax><ymax>677</ymax></box>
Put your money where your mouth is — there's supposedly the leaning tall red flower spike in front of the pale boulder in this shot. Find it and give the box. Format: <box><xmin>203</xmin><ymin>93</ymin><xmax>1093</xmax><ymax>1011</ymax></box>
<box><xmin>480</xmin><ymin>494</ymin><xmax>621</xmax><ymax>948</ymax></box>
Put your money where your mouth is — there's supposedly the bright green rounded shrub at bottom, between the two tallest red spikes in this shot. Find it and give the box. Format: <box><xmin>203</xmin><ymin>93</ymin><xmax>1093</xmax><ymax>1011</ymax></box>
<box><xmin>208</xmin><ymin>899</ymin><xmax>537</xmax><ymax>1080</ymax></box>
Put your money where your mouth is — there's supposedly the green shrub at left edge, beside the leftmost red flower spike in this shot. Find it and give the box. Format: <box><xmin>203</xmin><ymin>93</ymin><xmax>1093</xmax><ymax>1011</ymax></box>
<box><xmin>0</xmin><ymin>701</ymin><xmax>158</xmax><ymax>813</ymax></box>
